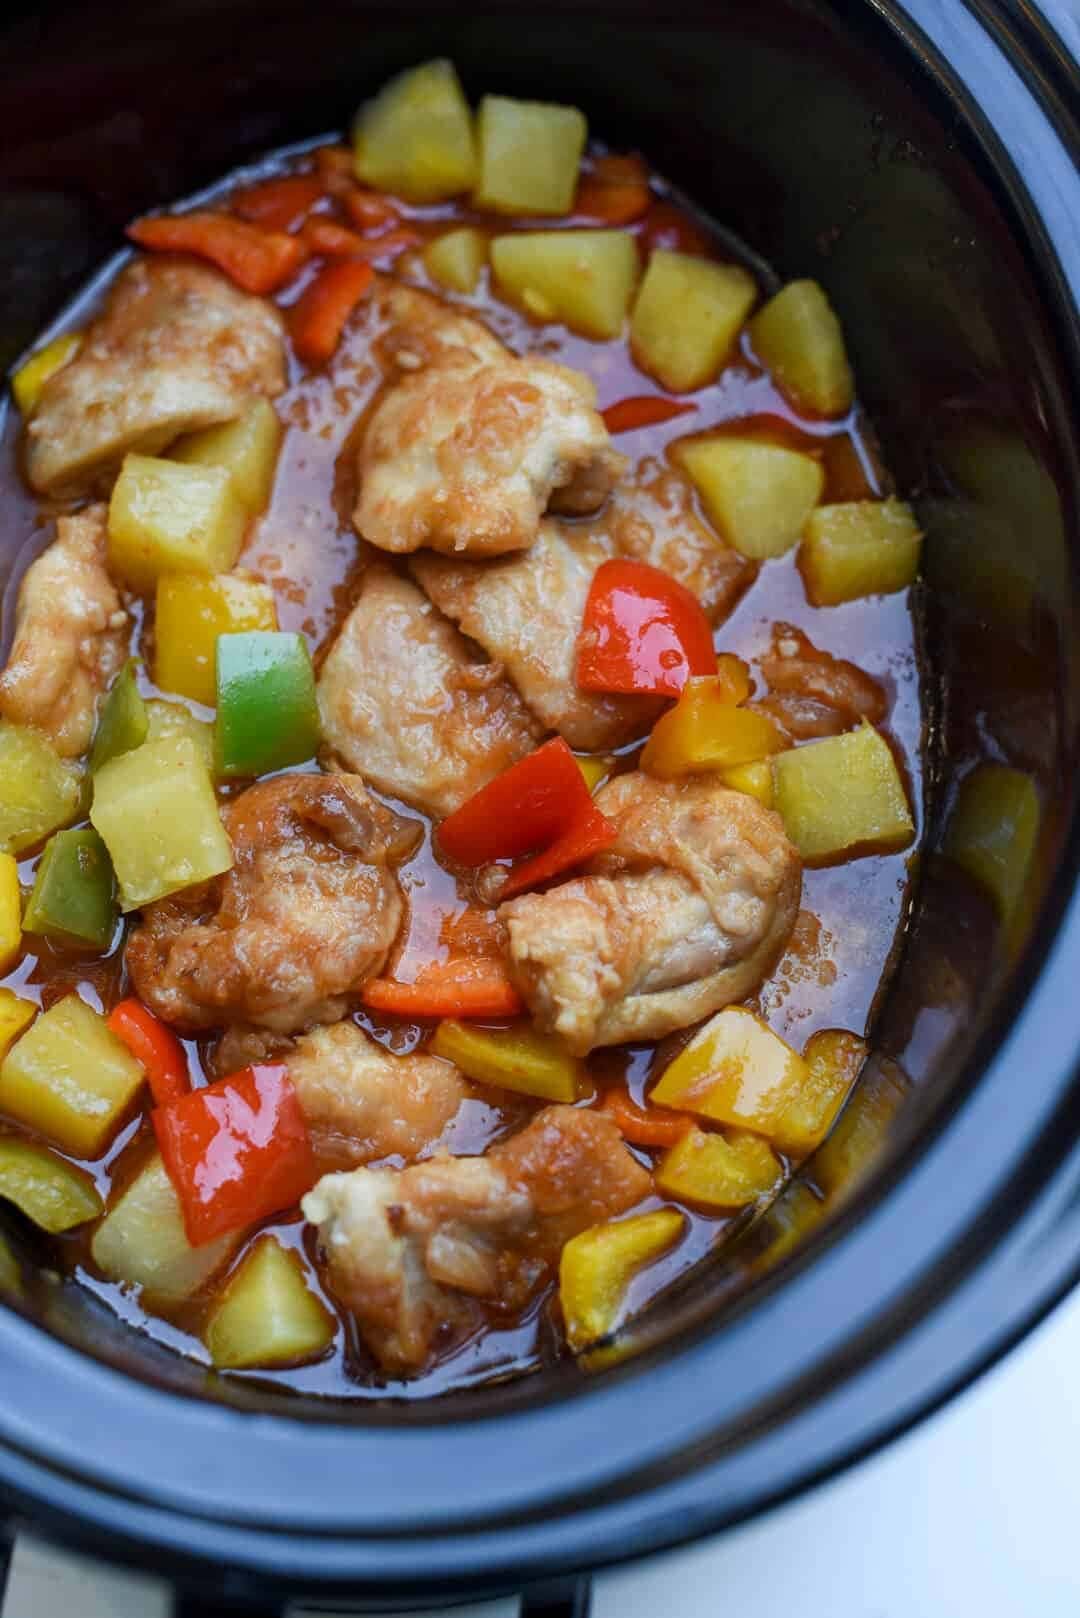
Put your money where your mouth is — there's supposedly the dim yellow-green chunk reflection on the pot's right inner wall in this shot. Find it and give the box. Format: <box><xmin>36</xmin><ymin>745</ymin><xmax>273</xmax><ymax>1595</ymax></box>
<box><xmin>944</xmin><ymin>764</ymin><xmax>1040</xmax><ymax>943</ymax></box>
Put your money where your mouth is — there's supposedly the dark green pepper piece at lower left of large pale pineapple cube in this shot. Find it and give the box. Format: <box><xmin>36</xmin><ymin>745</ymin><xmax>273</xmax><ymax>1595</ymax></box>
<box><xmin>23</xmin><ymin>827</ymin><xmax>117</xmax><ymax>950</ymax></box>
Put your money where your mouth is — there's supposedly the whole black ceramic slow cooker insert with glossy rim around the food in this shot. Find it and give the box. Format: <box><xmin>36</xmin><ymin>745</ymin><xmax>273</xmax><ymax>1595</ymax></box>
<box><xmin>0</xmin><ymin>0</ymin><xmax>1080</xmax><ymax>1612</ymax></box>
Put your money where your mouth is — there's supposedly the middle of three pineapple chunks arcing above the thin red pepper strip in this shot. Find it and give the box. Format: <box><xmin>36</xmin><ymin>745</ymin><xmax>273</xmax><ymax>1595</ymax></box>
<box><xmin>630</xmin><ymin>248</ymin><xmax>758</xmax><ymax>393</ymax></box>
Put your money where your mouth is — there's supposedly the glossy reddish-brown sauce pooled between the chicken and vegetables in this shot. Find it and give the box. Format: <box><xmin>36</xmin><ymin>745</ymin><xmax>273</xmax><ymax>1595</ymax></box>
<box><xmin>0</xmin><ymin>142</ymin><xmax>921</xmax><ymax>1398</ymax></box>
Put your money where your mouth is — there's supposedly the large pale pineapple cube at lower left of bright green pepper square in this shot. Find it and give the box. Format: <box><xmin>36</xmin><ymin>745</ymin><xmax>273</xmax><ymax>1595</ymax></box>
<box><xmin>91</xmin><ymin>738</ymin><xmax>233</xmax><ymax>911</ymax></box>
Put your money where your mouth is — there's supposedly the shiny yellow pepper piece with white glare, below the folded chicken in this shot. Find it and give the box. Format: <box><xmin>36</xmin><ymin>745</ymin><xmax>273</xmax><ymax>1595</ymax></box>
<box><xmin>649</xmin><ymin>1006</ymin><xmax>810</xmax><ymax>1152</ymax></box>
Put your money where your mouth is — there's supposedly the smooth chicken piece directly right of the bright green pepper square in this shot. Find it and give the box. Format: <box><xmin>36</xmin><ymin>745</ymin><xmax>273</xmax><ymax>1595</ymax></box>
<box><xmin>319</xmin><ymin>565</ymin><xmax>539</xmax><ymax>817</ymax></box>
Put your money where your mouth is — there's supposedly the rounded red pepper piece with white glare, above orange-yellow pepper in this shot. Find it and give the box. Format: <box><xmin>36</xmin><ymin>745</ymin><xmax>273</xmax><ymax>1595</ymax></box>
<box><xmin>578</xmin><ymin>560</ymin><xmax>716</xmax><ymax>697</ymax></box>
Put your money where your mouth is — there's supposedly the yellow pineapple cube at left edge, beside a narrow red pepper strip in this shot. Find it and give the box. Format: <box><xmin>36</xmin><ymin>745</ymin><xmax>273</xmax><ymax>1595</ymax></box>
<box><xmin>0</xmin><ymin>995</ymin><xmax>142</xmax><ymax>1157</ymax></box>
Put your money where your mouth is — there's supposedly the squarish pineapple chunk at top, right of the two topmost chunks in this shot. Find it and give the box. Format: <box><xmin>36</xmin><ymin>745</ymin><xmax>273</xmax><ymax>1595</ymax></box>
<box><xmin>473</xmin><ymin>95</ymin><xmax>588</xmax><ymax>214</ymax></box>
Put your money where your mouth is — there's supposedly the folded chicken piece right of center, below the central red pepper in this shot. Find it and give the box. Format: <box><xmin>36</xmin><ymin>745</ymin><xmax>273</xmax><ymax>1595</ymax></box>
<box><xmin>499</xmin><ymin>773</ymin><xmax>801</xmax><ymax>1053</ymax></box>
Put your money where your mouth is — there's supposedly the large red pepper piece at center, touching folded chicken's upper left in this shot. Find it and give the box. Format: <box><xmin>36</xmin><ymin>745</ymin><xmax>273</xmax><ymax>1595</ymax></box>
<box><xmin>436</xmin><ymin>736</ymin><xmax>593</xmax><ymax>866</ymax></box>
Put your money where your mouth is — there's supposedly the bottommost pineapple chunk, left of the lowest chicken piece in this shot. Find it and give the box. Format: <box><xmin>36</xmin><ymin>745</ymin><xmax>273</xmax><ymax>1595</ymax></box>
<box><xmin>206</xmin><ymin>1236</ymin><xmax>335</xmax><ymax>1370</ymax></box>
